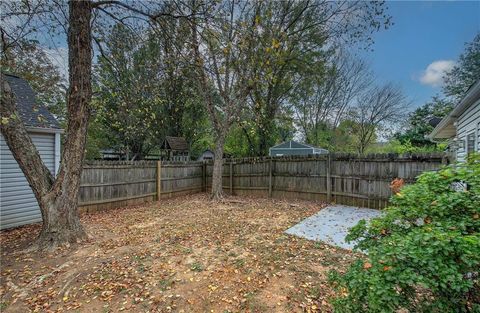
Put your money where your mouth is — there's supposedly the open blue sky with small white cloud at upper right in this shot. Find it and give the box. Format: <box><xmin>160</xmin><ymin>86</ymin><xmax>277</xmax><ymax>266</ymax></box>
<box><xmin>361</xmin><ymin>1</ymin><xmax>480</xmax><ymax>107</ymax></box>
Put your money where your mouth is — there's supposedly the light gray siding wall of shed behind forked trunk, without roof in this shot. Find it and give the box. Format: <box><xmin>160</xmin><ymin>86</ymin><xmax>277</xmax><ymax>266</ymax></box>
<box><xmin>0</xmin><ymin>133</ymin><xmax>55</xmax><ymax>229</ymax></box>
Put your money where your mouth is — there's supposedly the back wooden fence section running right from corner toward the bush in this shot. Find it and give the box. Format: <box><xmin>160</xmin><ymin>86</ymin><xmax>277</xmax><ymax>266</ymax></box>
<box><xmin>206</xmin><ymin>153</ymin><xmax>448</xmax><ymax>209</ymax></box>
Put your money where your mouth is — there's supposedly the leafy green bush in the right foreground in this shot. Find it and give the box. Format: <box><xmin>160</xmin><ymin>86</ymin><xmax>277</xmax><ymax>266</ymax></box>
<box><xmin>331</xmin><ymin>160</ymin><xmax>480</xmax><ymax>313</ymax></box>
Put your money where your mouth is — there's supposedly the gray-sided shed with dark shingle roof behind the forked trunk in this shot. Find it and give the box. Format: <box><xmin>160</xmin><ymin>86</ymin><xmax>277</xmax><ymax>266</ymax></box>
<box><xmin>0</xmin><ymin>74</ymin><xmax>63</xmax><ymax>229</ymax></box>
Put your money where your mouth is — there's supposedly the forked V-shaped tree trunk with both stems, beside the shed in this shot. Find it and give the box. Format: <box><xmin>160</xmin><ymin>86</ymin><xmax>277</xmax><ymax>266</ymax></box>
<box><xmin>0</xmin><ymin>1</ymin><xmax>92</xmax><ymax>250</ymax></box>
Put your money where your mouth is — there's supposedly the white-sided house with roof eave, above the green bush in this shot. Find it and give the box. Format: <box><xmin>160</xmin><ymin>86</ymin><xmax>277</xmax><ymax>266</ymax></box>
<box><xmin>428</xmin><ymin>80</ymin><xmax>480</xmax><ymax>162</ymax></box>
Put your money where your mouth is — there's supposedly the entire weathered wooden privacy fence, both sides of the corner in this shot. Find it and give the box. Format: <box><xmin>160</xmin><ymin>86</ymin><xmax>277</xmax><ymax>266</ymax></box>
<box><xmin>79</xmin><ymin>153</ymin><xmax>447</xmax><ymax>211</ymax></box>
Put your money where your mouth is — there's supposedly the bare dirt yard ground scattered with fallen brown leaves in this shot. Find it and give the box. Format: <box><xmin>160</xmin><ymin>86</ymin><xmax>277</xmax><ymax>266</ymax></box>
<box><xmin>0</xmin><ymin>195</ymin><xmax>356</xmax><ymax>312</ymax></box>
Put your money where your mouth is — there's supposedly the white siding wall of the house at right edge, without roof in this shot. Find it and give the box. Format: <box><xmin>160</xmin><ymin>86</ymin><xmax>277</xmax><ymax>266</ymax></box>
<box><xmin>455</xmin><ymin>99</ymin><xmax>480</xmax><ymax>162</ymax></box>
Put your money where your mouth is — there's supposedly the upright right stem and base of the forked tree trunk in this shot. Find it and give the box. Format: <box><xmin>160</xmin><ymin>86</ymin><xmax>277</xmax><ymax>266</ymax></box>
<box><xmin>39</xmin><ymin>0</ymin><xmax>92</xmax><ymax>246</ymax></box>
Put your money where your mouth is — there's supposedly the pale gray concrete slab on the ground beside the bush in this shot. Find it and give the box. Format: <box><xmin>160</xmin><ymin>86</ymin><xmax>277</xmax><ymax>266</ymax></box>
<box><xmin>286</xmin><ymin>205</ymin><xmax>382</xmax><ymax>249</ymax></box>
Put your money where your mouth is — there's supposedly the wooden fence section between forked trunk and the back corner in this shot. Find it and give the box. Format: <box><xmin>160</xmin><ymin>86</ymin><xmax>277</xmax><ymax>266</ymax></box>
<box><xmin>79</xmin><ymin>161</ymin><xmax>205</xmax><ymax>212</ymax></box>
